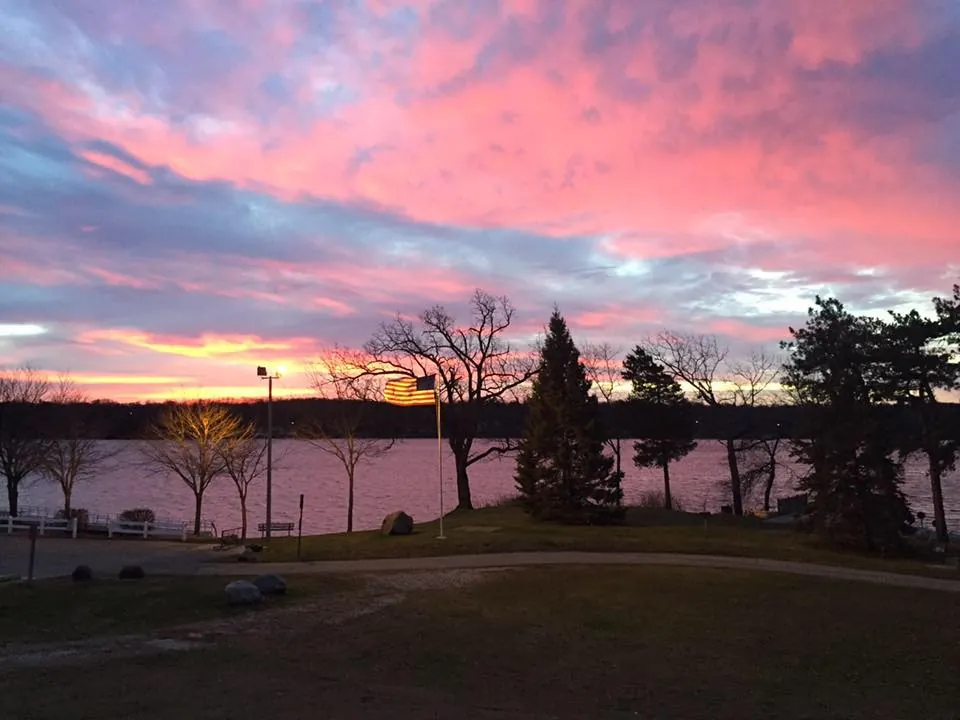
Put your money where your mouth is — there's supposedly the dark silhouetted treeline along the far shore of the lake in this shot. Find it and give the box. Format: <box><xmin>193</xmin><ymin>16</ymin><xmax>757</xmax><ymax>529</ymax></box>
<box><xmin>8</xmin><ymin>398</ymin><xmax>960</xmax><ymax>440</ymax></box>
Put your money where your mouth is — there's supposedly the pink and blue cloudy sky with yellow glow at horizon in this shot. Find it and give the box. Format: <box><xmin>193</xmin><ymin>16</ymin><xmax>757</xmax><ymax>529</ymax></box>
<box><xmin>0</xmin><ymin>0</ymin><xmax>960</xmax><ymax>400</ymax></box>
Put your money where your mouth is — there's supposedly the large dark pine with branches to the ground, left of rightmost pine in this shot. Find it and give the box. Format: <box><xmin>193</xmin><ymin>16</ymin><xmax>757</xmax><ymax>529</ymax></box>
<box><xmin>784</xmin><ymin>297</ymin><xmax>912</xmax><ymax>550</ymax></box>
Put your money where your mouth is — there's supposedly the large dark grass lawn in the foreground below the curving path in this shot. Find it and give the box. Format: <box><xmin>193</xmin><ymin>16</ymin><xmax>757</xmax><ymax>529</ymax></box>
<box><xmin>0</xmin><ymin>567</ymin><xmax>960</xmax><ymax>720</ymax></box>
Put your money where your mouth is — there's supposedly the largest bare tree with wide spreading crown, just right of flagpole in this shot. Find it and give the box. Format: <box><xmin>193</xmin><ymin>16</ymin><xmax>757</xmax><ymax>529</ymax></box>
<box><xmin>338</xmin><ymin>290</ymin><xmax>537</xmax><ymax>509</ymax></box>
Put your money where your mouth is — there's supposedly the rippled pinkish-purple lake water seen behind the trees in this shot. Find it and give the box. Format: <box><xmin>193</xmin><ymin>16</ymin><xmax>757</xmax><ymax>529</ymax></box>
<box><xmin>7</xmin><ymin>439</ymin><xmax>960</xmax><ymax>534</ymax></box>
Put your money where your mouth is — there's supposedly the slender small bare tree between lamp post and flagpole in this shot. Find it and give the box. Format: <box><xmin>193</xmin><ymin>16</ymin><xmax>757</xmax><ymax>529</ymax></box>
<box><xmin>308</xmin><ymin>349</ymin><xmax>395</xmax><ymax>532</ymax></box>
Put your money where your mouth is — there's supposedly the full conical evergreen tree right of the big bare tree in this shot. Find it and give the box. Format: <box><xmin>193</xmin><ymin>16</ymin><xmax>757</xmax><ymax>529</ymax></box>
<box><xmin>516</xmin><ymin>309</ymin><xmax>623</xmax><ymax>522</ymax></box>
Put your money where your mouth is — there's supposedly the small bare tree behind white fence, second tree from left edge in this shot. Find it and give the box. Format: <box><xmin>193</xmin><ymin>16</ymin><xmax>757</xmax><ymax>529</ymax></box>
<box><xmin>40</xmin><ymin>375</ymin><xmax>119</xmax><ymax>518</ymax></box>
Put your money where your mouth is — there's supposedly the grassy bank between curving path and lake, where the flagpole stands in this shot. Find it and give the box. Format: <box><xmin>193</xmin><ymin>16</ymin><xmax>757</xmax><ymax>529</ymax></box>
<box><xmin>251</xmin><ymin>506</ymin><xmax>960</xmax><ymax>579</ymax></box>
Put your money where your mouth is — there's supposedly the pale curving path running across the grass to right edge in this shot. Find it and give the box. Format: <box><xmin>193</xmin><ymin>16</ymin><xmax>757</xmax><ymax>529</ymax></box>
<box><xmin>198</xmin><ymin>552</ymin><xmax>960</xmax><ymax>592</ymax></box>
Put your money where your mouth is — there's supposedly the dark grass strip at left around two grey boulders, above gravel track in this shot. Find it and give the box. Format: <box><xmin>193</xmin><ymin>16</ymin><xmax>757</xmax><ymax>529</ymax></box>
<box><xmin>0</xmin><ymin>576</ymin><xmax>351</xmax><ymax>644</ymax></box>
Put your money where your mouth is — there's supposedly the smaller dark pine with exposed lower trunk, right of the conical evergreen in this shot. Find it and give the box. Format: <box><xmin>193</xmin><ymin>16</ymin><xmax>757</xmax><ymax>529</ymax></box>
<box><xmin>623</xmin><ymin>345</ymin><xmax>697</xmax><ymax>510</ymax></box>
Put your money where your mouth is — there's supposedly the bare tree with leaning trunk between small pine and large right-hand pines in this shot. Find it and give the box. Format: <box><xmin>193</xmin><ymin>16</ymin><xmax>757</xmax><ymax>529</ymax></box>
<box><xmin>646</xmin><ymin>332</ymin><xmax>780</xmax><ymax>515</ymax></box>
